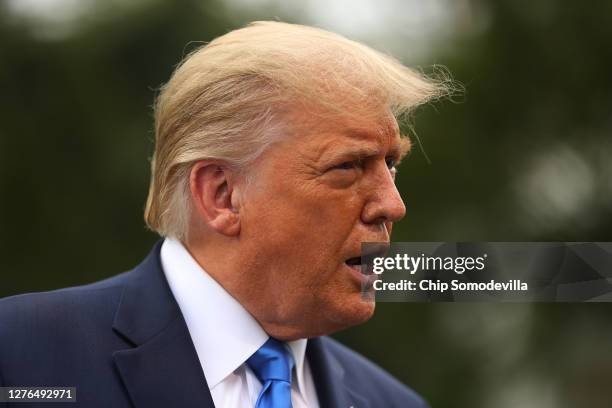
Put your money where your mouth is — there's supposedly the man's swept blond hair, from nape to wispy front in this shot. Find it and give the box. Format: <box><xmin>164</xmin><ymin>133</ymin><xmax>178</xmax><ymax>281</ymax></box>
<box><xmin>145</xmin><ymin>21</ymin><xmax>448</xmax><ymax>239</ymax></box>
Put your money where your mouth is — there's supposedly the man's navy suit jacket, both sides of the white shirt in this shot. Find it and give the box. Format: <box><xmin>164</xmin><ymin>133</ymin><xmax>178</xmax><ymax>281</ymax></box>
<box><xmin>0</xmin><ymin>242</ymin><xmax>427</xmax><ymax>408</ymax></box>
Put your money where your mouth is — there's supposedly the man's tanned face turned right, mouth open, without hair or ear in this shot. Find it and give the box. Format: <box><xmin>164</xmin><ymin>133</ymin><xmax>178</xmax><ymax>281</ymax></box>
<box><xmin>239</xmin><ymin>104</ymin><xmax>408</xmax><ymax>339</ymax></box>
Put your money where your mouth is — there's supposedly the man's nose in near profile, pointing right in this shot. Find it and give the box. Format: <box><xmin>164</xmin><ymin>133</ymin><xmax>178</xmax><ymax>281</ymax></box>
<box><xmin>361</xmin><ymin>164</ymin><xmax>406</xmax><ymax>224</ymax></box>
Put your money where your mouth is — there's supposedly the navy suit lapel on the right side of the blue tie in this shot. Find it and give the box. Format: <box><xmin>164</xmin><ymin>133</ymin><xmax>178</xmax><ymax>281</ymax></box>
<box><xmin>306</xmin><ymin>338</ymin><xmax>370</xmax><ymax>408</ymax></box>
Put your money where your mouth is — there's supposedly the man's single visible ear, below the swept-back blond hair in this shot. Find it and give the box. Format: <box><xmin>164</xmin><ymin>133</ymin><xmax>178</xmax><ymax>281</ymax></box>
<box><xmin>189</xmin><ymin>160</ymin><xmax>241</xmax><ymax>236</ymax></box>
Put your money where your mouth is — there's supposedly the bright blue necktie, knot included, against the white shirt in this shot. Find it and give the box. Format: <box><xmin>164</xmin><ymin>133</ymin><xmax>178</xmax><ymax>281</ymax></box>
<box><xmin>247</xmin><ymin>337</ymin><xmax>293</xmax><ymax>408</ymax></box>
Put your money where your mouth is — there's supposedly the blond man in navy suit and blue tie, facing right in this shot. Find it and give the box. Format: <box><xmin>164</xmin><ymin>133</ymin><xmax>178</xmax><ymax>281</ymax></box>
<box><xmin>0</xmin><ymin>22</ymin><xmax>443</xmax><ymax>408</ymax></box>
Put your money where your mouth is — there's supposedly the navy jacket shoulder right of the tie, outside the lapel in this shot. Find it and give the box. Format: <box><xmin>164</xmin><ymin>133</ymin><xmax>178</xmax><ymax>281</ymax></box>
<box><xmin>321</xmin><ymin>337</ymin><xmax>429</xmax><ymax>408</ymax></box>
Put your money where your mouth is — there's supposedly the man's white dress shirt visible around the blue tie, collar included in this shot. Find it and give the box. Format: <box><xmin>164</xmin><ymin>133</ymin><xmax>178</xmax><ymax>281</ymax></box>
<box><xmin>161</xmin><ymin>238</ymin><xmax>319</xmax><ymax>408</ymax></box>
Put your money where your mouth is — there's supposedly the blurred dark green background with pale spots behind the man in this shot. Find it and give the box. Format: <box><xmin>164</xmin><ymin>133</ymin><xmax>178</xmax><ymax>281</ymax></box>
<box><xmin>0</xmin><ymin>0</ymin><xmax>612</xmax><ymax>408</ymax></box>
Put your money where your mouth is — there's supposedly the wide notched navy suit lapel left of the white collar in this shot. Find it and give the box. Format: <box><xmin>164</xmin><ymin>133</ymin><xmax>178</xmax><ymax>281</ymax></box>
<box><xmin>113</xmin><ymin>242</ymin><xmax>214</xmax><ymax>408</ymax></box>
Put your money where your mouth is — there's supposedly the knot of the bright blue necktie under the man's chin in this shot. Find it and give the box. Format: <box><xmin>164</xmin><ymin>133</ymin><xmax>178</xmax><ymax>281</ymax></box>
<box><xmin>247</xmin><ymin>337</ymin><xmax>294</xmax><ymax>384</ymax></box>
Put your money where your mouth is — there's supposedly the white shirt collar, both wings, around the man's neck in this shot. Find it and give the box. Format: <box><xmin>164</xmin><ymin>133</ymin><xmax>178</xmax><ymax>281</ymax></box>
<box><xmin>161</xmin><ymin>238</ymin><xmax>306</xmax><ymax>395</ymax></box>
